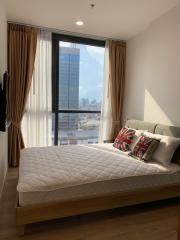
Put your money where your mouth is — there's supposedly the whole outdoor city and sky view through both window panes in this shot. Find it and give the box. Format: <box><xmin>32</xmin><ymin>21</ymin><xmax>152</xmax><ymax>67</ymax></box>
<box><xmin>53</xmin><ymin>41</ymin><xmax>104</xmax><ymax>144</ymax></box>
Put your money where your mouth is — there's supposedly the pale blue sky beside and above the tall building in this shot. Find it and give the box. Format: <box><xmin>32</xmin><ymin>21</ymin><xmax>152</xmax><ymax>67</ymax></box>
<box><xmin>60</xmin><ymin>42</ymin><xmax>105</xmax><ymax>102</ymax></box>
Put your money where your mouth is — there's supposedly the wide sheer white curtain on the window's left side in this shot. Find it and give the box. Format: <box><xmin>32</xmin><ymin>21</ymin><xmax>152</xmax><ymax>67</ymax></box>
<box><xmin>22</xmin><ymin>30</ymin><xmax>52</xmax><ymax>147</ymax></box>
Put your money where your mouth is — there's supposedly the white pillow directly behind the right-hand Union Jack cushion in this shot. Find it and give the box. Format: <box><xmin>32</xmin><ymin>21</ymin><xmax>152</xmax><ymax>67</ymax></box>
<box><xmin>144</xmin><ymin>132</ymin><xmax>180</xmax><ymax>165</ymax></box>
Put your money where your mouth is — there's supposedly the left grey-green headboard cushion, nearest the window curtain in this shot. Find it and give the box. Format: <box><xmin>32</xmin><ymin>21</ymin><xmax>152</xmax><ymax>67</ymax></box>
<box><xmin>126</xmin><ymin>120</ymin><xmax>157</xmax><ymax>133</ymax></box>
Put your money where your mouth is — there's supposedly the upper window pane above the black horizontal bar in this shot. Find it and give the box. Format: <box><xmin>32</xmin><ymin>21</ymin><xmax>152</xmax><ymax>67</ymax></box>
<box><xmin>59</xmin><ymin>41</ymin><xmax>105</xmax><ymax>110</ymax></box>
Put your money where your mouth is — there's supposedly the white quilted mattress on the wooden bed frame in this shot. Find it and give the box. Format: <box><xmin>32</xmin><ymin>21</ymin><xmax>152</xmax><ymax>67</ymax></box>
<box><xmin>17</xmin><ymin>144</ymin><xmax>180</xmax><ymax>206</ymax></box>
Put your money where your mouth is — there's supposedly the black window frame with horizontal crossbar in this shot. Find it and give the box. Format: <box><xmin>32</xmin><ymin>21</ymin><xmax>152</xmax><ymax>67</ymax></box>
<box><xmin>52</xmin><ymin>33</ymin><xmax>105</xmax><ymax>145</ymax></box>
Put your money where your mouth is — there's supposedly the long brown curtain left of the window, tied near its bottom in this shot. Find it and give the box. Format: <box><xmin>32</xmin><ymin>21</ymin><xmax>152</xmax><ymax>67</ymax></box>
<box><xmin>7</xmin><ymin>24</ymin><xmax>37</xmax><ymax>167</ymax></box>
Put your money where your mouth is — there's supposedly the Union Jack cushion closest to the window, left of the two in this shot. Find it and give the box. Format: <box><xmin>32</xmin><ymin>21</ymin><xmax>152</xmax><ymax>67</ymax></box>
<box><xmin>113</xmin><ymin>127</ymin><xmax>135</xmax><ymax>152</ymax></box>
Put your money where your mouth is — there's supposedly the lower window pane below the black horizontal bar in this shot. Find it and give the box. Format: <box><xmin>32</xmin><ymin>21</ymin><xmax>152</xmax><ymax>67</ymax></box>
<box><xmin>58</xmin><ymin>113</ymin><xmax>100</xmax><ymax>145</ymax></box>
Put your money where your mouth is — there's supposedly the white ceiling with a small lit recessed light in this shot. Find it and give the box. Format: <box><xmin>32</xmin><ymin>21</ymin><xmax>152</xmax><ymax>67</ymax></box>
<box><xmin>5</xmin><ymin>0</ymin><xmax>180</xmax><ymax>40</ymax></box>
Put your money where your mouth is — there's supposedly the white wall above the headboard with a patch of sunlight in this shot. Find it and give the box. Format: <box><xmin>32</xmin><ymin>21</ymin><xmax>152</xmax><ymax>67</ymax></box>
<box><xmin>123</xmin><ymin>7</ymin><xmax>180</xmax><ymax>126</ymax></box>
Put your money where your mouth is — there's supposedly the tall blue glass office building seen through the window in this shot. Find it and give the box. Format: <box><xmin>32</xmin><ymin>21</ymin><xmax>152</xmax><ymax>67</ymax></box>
<box><xmin>59</xmin><ymin>47</ymin><xmax>80</xmax><ymax>130</ymax></box>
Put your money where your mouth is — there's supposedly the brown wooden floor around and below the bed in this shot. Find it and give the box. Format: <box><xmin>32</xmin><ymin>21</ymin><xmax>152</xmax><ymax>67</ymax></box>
<box><xmin>0</xmin><ymin>169</ymin><xmax>178</xmax><ymax>240</ymax></box>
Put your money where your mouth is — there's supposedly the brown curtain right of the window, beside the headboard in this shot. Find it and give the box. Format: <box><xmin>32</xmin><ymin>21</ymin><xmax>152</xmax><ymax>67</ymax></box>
<box><xmin>109</xmin><ymin>41</ymin><xmax>126</xmax><ymax>140</ymax></box>
